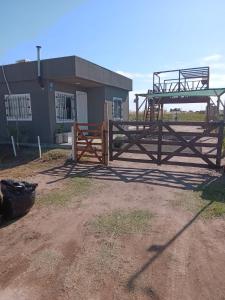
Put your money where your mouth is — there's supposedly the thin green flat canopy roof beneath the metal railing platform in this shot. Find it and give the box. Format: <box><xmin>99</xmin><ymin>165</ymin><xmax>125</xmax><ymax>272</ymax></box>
<box><xmin>136</xmin><ymin>88</ymin><xmax>225</xmax><ymax>99</ymax></box>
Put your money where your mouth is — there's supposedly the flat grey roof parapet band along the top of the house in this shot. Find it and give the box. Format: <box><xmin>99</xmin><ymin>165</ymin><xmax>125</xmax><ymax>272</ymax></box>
<box><xmin>0</xmin><ymin>55</ymin><xmax>132</xmax><ymax>91</ymax></box>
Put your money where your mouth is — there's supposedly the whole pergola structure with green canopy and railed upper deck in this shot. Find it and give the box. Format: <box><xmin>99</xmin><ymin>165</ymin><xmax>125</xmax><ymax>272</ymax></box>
<box><xmin>134</xmin><ymin>67</ymin><xmax>225</xmax><ymax>122</ymax></box>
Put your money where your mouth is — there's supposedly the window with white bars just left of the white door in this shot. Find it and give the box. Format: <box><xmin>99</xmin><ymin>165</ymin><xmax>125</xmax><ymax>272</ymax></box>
<box><xmin>55</xmin><ymin>92</ymin><xmax>75</xmax><ymax>123</ymax></box>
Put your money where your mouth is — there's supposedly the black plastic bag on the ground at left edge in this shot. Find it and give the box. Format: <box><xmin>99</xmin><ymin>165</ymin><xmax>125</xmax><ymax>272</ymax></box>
<box><xmin>1</xmin><ymin>180</ymin><xmax>37</xmax><ymax>219</ymax></box>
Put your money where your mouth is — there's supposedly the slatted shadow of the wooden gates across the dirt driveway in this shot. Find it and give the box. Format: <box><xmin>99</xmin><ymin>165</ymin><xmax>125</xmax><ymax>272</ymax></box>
<box><xmin>41</xmin><ymin>163</ymin><xmax>218</xmax><ymax>190</ymax></box>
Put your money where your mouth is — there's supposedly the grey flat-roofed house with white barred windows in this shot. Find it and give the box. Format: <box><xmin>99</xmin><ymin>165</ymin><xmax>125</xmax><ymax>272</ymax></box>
<box><xmin>0</xmin><ymin>56</ymin><xmax>132</xmax><ymax>143</ymax></box>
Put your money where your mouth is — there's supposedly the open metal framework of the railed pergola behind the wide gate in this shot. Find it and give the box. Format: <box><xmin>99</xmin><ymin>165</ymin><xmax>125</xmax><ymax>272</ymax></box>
<box><xmin>134</xmin><ymin>67</ymin><xmax>225</xmax><ymax>122</ymax></box>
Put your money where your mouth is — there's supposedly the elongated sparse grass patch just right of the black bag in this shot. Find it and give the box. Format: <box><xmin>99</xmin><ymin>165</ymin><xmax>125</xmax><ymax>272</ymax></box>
<box><xmin>37</xmin><ymin>177</ymin><xmax>91</xmax><ymax>207</ymax></box>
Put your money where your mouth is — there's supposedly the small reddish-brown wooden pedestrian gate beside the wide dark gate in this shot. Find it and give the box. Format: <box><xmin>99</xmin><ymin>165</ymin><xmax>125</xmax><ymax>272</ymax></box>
<box><xmin>73</xmin><ymin>122</ymin><xmax>108</xmax><ymax>164</ymax></box>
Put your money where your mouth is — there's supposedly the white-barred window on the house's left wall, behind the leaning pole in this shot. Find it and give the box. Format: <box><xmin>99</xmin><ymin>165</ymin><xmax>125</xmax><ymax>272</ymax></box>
<box><xmin>5</xmin><ymin>94</ymin><xmax>32</xmax><ymax>121</ymax></box>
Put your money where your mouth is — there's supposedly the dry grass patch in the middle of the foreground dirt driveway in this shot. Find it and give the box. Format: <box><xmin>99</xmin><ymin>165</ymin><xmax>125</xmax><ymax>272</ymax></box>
<box><xmin>90</xmin><ymin>210</ymin><xmax>152</xmax><ymax>236</ymax></box>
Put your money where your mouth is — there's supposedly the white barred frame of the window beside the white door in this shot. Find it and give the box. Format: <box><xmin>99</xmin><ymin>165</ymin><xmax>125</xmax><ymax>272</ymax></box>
<box><xmin>55</xmin><ymin>91</ymin><xmax>76</xmax><ymax>123</ymax></box>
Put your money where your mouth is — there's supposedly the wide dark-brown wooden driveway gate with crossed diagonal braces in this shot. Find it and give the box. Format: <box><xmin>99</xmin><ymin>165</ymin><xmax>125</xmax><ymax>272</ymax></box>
<box><xmin>109</xmin><ymin>121</ymin><xmax>224</xmax><ymax>168</ymax></box>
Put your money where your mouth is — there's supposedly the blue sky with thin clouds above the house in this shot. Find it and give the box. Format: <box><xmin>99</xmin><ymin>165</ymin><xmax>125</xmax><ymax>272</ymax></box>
<box><xmin>0</xmin><ymin>0</ymin><xmax>225</xmax><ymax>109</ymax></box>
